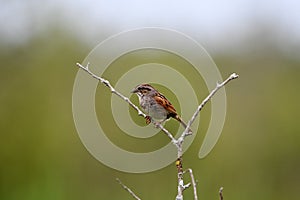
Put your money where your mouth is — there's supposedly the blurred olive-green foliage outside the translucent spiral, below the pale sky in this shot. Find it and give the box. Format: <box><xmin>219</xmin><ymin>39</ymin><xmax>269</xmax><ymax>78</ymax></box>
<box><xmin>0</xmin><ymin>25</ymin><xmax>300</xmax><ymax>200</ymax></box>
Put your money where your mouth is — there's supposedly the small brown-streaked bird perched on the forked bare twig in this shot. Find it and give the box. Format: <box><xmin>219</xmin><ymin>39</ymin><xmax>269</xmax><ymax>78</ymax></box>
<box><xmin>131</xmin><ymin>83</ymin><xmax>192</xmax><ymax>132</ymax></box>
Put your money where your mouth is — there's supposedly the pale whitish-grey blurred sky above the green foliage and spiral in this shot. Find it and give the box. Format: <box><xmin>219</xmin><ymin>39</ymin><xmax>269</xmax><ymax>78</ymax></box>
<box><xmin>0</xmin><ymin>0</ymin><xmax>300</xmax><ymax>54</ymax></box>
